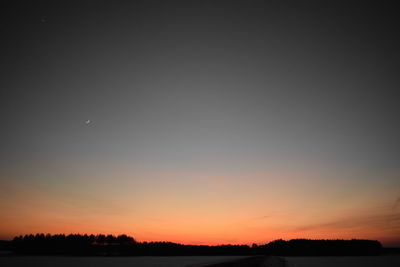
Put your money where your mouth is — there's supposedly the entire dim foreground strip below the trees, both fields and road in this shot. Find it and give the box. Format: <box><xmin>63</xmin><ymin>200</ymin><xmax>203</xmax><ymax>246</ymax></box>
<box><xmin>0</xmin><ymin>255</ymin><xmax>400</xmax><ymax>267</ymax></box>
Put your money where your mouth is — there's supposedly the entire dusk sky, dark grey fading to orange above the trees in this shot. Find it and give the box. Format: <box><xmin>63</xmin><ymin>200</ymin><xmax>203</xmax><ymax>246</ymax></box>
<box><xmin>0</xmin><ymin>0</ymin><xmax>400</xmax><ymax>246</ymax></box>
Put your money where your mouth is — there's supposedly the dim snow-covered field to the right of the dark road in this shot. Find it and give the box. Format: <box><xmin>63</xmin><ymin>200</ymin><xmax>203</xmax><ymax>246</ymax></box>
<box><xmin>285</xmin><ymin>255</ymin><xmax>400</xmax><ymax>267</ymax></box>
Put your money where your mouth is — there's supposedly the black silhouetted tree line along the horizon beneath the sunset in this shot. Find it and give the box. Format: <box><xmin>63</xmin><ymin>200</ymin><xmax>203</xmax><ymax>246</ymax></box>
<box><xmin>0</xmin><ymin>234</ymin><xmax>383</xmax><ymax>256</ymax></box>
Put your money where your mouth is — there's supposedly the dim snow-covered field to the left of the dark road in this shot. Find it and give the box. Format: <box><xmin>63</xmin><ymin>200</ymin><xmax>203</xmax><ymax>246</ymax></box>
<box><xmin>0</xmin><ymin>256</ymin><xmax>250</xmax><ymax>267</ymax></box>
